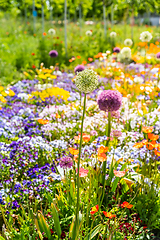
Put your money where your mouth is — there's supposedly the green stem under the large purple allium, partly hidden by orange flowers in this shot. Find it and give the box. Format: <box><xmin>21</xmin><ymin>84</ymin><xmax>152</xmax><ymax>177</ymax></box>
<box><xmin>102</xmin><ymin>112</ymin><xmax>111</xmax><ymax>197</ymax></box>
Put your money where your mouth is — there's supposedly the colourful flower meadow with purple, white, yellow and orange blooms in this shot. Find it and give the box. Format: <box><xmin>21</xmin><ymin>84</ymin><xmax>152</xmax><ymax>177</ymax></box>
<box><xmin>0</xmin><ymin>14</ymin><xmax>160</xmax><ymax>240</ymax></box>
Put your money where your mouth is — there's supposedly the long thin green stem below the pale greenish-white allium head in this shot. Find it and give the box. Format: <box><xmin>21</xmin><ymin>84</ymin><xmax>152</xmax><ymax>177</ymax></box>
<box><xmin>75</xmin><ymin>93</ymin><xmax>86</xmax><ymax>236</ymax></box>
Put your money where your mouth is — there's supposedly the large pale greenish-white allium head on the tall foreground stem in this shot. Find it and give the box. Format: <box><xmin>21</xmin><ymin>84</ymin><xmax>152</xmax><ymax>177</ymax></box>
<box><xmin>75</xmin><ymin>69</ymin><xmax>98</xmax><ymax>93</ymax></box>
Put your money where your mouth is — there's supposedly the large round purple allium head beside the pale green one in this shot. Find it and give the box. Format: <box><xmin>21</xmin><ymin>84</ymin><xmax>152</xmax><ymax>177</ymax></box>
<box><xmin>97</xmin><ymin>90</ymin><xmax>122</xmax><ymax>112</ymax></box>
